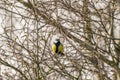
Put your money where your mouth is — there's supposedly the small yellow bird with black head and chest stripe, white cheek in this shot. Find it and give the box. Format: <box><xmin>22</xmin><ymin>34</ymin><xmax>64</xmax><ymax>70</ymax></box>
<box><xmin>52</xmin><ymin>39</ymin><xmax>64</xmax><ymax>55</ymax></box>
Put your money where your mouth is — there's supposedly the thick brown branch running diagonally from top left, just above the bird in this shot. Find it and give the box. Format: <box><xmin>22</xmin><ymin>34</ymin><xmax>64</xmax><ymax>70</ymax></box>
<box><xmin>18</xmin><ymin>0</ymin><xmax>120</xmax><ymax>70</ymax></box>
